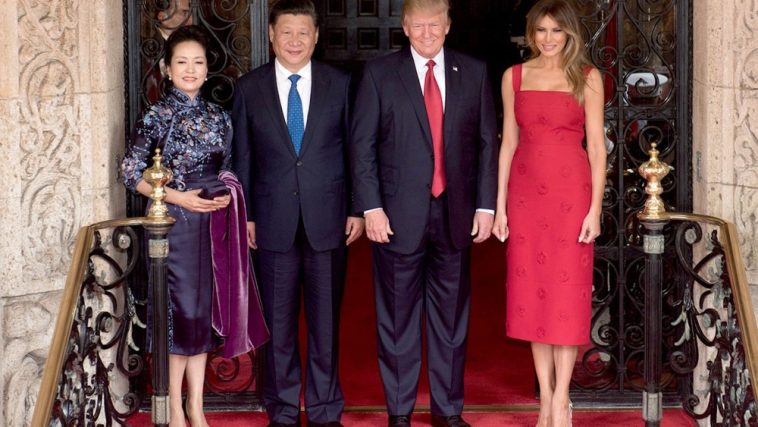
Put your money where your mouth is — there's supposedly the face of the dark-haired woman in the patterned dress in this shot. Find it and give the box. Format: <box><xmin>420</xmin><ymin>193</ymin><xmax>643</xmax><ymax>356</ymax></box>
<box><xmin>166</xmin><ymin>40</ymin><xmax>208</xmax><ymax>98</ymax></box>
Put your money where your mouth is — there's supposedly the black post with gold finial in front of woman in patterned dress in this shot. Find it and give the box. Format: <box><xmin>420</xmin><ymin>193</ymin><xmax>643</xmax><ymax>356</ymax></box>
<box><xmin>143</xmin><ymin>149</ymin><xmax>175</xmax><ymax>426</ymax></box>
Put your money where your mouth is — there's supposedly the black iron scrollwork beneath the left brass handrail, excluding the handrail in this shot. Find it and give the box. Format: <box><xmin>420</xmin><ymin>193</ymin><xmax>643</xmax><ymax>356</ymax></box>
<box><xmin>50</xmin><ymin>226</ymin><xmax>145</xmax><ymax>426</ymax></box>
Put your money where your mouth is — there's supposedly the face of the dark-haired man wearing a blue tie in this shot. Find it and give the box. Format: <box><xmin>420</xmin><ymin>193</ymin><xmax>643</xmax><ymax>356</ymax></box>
<box><xmin>268</xmin><ymin>14</ymin><xmax>318</xmax><ymax>73</ymax></box>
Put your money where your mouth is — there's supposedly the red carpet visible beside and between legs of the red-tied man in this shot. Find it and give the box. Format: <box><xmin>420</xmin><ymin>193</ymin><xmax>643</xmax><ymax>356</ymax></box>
<box><xmin>340</xmin><ymin>238</ymin><xmax>536</xmax><ymax>408</ymax></box>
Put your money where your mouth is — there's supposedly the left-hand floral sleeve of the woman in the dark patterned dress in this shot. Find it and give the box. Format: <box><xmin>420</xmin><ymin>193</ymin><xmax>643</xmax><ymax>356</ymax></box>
<box><xmin>121</xmin><ymin>110</ymin><xmax>157</xmax><ymax>192</ymax></box>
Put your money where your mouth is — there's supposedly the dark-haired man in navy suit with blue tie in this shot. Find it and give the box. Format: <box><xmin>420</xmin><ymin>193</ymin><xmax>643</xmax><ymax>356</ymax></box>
<box><xmin>232</xmin><ymin>0</ymin><xmax>363</xmax><ymax>427</ymax></box>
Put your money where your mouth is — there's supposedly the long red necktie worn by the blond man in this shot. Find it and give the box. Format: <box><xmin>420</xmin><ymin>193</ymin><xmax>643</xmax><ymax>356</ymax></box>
<box><xmin>424</xmin><ymin>59</ymin><xmax>447</xmax><ymax>197</ymax></box>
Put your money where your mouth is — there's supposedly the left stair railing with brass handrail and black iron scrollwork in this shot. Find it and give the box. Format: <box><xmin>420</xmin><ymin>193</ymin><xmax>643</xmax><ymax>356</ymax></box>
<box><xmin>32</xmin><ymin>218</ymin><xmax>145</xmax><ymax>426</ymax></box>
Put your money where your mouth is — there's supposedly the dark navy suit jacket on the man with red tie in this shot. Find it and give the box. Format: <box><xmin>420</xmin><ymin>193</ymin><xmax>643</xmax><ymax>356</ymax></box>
<box><xmin>350</xmin><ymin>47</ymin><xmax>498</xmax><ymax>253</ymax></box>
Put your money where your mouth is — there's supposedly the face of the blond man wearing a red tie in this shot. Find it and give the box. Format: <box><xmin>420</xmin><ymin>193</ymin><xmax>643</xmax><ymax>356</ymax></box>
<box><xmin>403</xmin><ymin>9</ymin><xmax>450</xmax><ymax>59</ymax></box>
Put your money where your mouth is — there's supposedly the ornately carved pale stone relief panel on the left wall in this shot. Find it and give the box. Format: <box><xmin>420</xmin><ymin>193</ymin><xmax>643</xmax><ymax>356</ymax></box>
<box><xmin>18</xmin><ymin>0</ymin><xmax>82</xmax><ymax>281</ymax></box>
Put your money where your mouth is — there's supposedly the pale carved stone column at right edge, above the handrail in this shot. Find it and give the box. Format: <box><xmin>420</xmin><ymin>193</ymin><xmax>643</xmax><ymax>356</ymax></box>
<box><xmin>692</xmin><ymin>0</ymin><xmax>758</xmax><ymax>296</ymax></box>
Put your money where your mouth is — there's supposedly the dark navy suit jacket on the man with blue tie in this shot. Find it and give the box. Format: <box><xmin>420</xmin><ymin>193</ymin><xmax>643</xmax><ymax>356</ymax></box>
<box><xmin>232</xmin><ymin>61</ymin><xmax>350</xmax><ymax>252</ymax></box>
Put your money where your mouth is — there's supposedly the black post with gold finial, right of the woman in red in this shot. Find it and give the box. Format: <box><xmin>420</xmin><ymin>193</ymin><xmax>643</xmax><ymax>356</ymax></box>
<box><xmin>637</xmin><ymin>144</ymin><xmax>671</xmax><ymax>427</ymax></box>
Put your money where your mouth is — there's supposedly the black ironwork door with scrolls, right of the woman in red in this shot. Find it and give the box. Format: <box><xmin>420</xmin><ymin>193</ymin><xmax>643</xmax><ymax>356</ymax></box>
<box><xmin>572</xmin><ymin>0</ymin><xmax>692</xmax><ymax>404</ymax></box>
